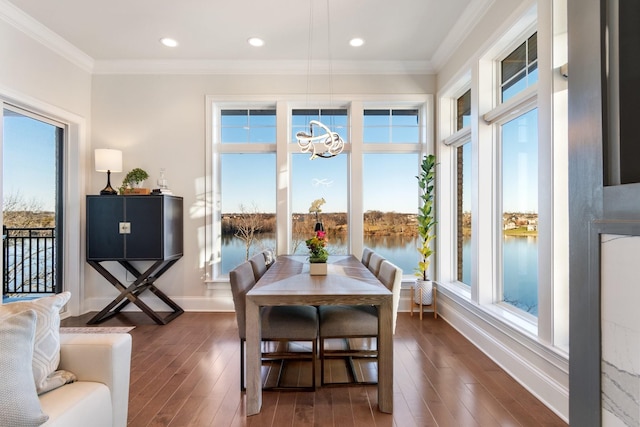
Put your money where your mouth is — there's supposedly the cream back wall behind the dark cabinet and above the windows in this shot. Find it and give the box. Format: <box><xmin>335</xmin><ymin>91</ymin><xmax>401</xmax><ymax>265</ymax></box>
<box><xmin>85</xmin><ymin>74</ymin><xmax>435</xmax><ymax>310</ymax></box>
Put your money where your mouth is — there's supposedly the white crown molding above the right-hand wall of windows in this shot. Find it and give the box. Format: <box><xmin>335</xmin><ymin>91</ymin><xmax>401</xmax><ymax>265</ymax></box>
<box><xmin>431</xmin><ymin>0</ymin><xmax>495</xmax><ymax>73</ymax></box>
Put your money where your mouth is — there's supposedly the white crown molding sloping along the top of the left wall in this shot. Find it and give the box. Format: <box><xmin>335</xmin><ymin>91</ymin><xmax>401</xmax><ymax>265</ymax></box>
<box><xmin>0</xmin><ymin>0</ymin><xmax>94</xmax><ymax>73</ymax></box>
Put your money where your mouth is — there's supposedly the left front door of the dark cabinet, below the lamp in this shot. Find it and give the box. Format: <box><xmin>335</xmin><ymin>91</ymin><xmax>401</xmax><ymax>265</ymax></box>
<box><xmin>87</xmin><ymin>196</ymin><xmax>124</xmax><ymax>260</ymax></box>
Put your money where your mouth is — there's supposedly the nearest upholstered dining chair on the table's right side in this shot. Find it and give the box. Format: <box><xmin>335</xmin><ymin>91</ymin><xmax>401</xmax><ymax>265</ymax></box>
<box><xmin>318</xmin><ymin>260</ymin><xmax>402</xmax><ymax>385</ymax></box>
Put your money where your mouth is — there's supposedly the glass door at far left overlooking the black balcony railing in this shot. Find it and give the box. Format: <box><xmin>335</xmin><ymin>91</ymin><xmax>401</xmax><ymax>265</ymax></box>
<box><xmin>2</xmin><ymin>105</ymin><xmax>66</xmax><ymax>294</ymax></box>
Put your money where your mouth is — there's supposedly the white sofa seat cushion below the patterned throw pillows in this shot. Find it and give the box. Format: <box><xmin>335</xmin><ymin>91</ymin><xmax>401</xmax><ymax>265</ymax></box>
<box><xmin>40</xmin><ymin>381</ymin><xmax>113</xmax><ymax>427</ymax></box>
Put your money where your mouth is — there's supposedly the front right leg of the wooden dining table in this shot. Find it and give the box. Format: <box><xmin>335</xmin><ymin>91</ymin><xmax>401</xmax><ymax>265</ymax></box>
<box><xmin>378</xmin><ymin>297</ymin><xmax>393</xmax><ymax>414</ymax></box>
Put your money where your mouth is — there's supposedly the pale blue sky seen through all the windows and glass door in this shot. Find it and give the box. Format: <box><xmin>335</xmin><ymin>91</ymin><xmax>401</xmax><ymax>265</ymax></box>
<box><xmin>3</xmin><ymin>102</ymin><xmax>538</xmax><ymax>219</ymax></box>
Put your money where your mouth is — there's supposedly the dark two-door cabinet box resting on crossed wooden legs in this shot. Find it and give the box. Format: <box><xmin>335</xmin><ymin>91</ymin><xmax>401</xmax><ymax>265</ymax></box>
<box><xmin>87</xmin><ymin>195</ymin><xmax>183</xmax><ymax>261</ymax></box>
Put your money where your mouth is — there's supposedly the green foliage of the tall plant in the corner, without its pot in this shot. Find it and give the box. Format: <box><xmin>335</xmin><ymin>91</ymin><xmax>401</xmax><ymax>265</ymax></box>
<box><xmin>415</xmin><ymin>154</ymin><xmax>436</xmax><ymax>280</ymax></box>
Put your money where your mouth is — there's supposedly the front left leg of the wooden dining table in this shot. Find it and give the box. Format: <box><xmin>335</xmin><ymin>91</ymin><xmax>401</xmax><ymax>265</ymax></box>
<box><xmin>248</xmin><ymin>298</ymin><xmax>262</xmax><ymax>415</ymax></box>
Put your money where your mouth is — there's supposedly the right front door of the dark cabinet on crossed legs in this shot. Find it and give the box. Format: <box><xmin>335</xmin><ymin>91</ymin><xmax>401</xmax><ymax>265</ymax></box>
<box><xmin>125</xmin><ymin>196</ymin><xmax>163</xmax><ymax>260</ymax></box>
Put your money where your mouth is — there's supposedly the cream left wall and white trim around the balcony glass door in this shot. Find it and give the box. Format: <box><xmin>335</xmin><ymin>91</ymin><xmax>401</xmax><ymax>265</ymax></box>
<box><xmin>0</xmin><ymin>16</ymin><xmax>91</xmax><ymax>313</ymax></box>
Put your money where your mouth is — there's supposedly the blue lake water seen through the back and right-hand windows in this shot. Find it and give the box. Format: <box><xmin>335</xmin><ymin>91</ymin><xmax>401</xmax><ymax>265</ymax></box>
<box><xmin>222</xmin><ymin>233</ymin><xmax>538</xmax><ymax>316</ymax></box>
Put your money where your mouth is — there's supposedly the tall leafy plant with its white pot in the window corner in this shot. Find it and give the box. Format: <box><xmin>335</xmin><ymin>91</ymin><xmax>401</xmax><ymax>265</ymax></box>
<box><xmin>414</xmin><ymin>154</ymin><xmax>436</xmax><ymax>305</ymax></box>
